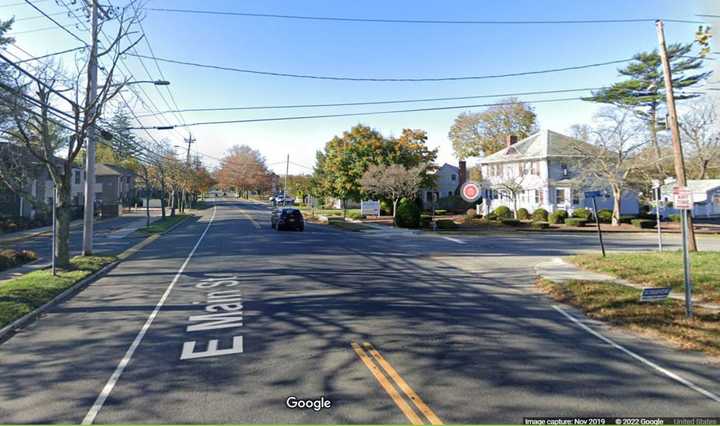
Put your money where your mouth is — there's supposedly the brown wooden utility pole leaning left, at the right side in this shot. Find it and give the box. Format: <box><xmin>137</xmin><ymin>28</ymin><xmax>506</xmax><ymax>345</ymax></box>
<box><xmin>655</xmin><ymin>19</ymin><xmax>697</xmax><ymax>251</ymax></box>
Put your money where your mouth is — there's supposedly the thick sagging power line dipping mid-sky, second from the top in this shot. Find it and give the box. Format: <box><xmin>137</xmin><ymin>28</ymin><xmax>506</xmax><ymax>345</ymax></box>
<box><xmin>126</xmin><ymin>53</ymin><xmax>633</xmax><ymax>82</ymax></box>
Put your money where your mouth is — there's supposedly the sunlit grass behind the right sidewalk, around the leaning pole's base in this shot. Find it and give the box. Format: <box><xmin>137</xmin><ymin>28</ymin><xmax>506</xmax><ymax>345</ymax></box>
<box><xmin>569</xmin><ymin>251</ymin><xmax>720</xmax><ymax>303</ymax></box>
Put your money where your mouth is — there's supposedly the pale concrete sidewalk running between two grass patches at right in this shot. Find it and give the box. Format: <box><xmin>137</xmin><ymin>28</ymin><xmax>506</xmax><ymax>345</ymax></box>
<box><xmin>535</xmin><ymin>257</ymin><xmax>720</xmax><ymax>311</ymax></box>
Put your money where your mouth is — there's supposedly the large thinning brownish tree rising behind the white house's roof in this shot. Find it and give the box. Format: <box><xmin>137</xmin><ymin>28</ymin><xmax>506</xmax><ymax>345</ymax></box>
<box><xmin>448</xmin><ymin>98</ymin><xmax>538</xmax><ymax>160</ymax></box>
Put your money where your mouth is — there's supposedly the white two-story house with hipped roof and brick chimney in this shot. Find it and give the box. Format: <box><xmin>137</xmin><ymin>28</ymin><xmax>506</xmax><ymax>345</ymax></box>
<box><xmin>480</xmin><ymin>130</ymin><xmax>640</xmax><ymax>214</ymax></box>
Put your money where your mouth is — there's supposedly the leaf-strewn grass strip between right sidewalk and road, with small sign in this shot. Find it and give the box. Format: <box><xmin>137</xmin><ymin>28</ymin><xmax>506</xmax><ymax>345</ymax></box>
<box><xmin>537</xmin><ymin>279</ymin><xmax>720</xmax><ymax>356</ymax></box>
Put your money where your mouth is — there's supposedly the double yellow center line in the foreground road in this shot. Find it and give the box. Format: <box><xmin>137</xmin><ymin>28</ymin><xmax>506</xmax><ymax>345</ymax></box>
<box><xmin>352</xmin><ymin>342</ymin><xmax>443</xmax><ymax>425</ymax></box>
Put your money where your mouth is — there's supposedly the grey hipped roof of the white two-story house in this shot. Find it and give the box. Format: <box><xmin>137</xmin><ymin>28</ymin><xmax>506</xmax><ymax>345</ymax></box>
<box><xmin>480</xmin><ymin>130</ymin><xmax>594</xmax><ymax>164</ymax></box>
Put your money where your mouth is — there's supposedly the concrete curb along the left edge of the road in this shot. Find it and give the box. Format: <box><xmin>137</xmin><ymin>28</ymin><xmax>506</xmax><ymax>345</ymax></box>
<box><xmin>0</xmin><ymin>216</ymin><xmax>193</xmax><ymax>343</ymax></box>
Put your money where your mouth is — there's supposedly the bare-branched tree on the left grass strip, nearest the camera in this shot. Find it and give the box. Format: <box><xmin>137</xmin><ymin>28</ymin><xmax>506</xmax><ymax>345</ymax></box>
<box><xmin>4</xmin><ymin>7</ymin><xmax>140</xmax><ymax>267</ymax></box>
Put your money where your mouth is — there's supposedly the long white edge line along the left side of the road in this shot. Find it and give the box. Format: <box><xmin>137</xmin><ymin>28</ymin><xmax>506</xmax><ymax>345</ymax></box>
<box><xmin>81</xmin><ymin>206</ymin><xmax>217</xmax><ymax>425</ymax></box>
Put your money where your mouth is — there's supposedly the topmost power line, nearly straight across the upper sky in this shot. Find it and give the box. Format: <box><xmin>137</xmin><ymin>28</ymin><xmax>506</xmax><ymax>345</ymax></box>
<box><xmin>145</xmin><ymin>7</ymin><xmax>704</xmax><ymax>25</ymax></box>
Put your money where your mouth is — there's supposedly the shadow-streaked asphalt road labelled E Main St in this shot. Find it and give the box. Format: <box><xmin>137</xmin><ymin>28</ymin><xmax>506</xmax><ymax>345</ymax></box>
<box><xmin>0</xmin><ymin>202</ymin><xmax>720</xmax><ymax>424</ymax></box>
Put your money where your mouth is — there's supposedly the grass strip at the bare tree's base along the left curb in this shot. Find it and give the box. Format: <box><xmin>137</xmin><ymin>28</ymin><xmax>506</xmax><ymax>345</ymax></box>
<box><xmin>0</xmin><ymin>256</ymin><xmax>115</xmax><ymax>327</ymax></box>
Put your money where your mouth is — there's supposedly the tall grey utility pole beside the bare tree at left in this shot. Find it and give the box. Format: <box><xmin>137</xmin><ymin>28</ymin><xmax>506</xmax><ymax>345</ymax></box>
<box><xmin>82</xmin><ymin>0</ymin><xmax>98</xmax><ymax>256</ymax></box>
